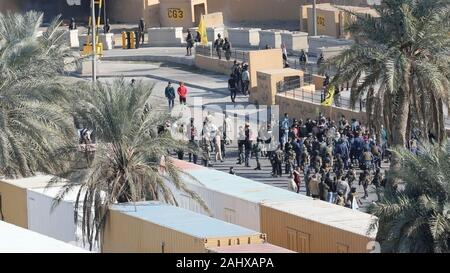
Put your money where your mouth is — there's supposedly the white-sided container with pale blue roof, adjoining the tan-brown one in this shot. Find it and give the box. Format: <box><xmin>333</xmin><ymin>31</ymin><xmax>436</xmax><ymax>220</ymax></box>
<box><xmin>168</xmin><ymin>160</ymin><xmax>301</xmax><ymax>232</ymax></box>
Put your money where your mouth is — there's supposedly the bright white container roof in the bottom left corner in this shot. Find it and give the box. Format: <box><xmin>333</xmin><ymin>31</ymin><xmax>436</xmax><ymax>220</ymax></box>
<box><xmin>0</xmin><ymin>221</ymin><xmax>88</xmax><ymax>253</ymax></box>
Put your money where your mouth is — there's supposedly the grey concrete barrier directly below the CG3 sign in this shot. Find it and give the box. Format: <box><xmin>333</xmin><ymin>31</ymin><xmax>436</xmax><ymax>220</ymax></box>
<box><xmin>147</xmin><ymin>27</ymin><xmax>185</xmax><ymax>46</ymax></box>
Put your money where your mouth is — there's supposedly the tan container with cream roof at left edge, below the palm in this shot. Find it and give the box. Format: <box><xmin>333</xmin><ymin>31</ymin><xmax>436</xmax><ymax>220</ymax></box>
<box><xmin>0</xmin><ymin>175</ymin><xmax>63</xmax><ymax>228</ymax></box>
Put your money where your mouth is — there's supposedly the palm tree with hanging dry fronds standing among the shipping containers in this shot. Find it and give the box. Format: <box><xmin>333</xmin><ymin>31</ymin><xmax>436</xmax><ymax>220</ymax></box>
<box><xmin>53</xmin><ymin>79</ymin><xmax>207</xmax><ymax>248</ymax></box>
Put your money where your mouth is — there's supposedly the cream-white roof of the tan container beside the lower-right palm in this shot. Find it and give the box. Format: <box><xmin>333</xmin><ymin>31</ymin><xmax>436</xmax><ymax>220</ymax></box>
<box><xmin>264</xmin><ymin>200</ymin><xmax>377</xmax><ymax>238</ymax></box>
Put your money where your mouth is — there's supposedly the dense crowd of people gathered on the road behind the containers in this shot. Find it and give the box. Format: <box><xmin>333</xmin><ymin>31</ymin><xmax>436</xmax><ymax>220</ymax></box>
<box><xmin>171</xmin><ymin>109</ymin><xmax>390</xmax><ymax>209</ymax></box>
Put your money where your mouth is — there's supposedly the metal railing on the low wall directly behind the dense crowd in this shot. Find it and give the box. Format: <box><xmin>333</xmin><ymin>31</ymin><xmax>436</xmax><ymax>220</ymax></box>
<box><xmin>277</xmin><ymin>76</ymin><xmax>366</xmax><ymax>112</ymax></box>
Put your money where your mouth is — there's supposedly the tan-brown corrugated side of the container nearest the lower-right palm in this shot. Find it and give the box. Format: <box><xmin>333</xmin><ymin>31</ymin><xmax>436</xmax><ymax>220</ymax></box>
<box><xmin>261</xmin><ymin>204</ymin><xmax>372</xmax><ymax>253</ymax></box>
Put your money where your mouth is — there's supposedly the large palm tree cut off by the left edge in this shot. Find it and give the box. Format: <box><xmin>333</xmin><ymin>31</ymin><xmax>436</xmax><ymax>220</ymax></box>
<box><xmin>0</xmin><ymin>12</ymin><xmax>74</xmax><ymax>177</ymax></box>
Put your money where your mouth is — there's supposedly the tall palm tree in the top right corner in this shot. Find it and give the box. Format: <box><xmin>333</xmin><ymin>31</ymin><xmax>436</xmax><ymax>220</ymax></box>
<box><xmin>327</xmin><ymin>0</ymin><xmax>450</xmax><ymax>147</ymax></box>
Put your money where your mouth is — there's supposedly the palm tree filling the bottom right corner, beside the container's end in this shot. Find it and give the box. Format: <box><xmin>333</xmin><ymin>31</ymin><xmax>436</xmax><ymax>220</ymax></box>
<box><xmin>370</xmin><ymin>142</ymin><xmax>450</xmax><ymax>252</ymax></box>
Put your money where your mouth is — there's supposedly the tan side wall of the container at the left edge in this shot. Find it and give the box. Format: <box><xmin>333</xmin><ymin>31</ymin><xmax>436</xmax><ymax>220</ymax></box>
<box><xmin>0</xmin><ymin>181</ymin><xmax>28</xmax><ymax>228</ymax></box>
